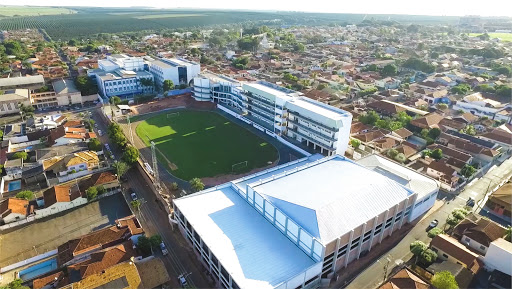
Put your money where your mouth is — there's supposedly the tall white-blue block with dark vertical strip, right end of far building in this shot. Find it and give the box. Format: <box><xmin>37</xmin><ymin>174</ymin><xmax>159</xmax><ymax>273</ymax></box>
<box><xmin>149</xmin><ymin>58</ymin><xmax>201</xmax><ymax>87</ymax></box>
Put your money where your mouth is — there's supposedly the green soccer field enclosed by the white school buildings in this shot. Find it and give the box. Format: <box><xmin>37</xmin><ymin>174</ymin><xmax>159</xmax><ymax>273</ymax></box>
<box><xmin>136</xmin><ymin>111</ymin><xmax>278</xmax><ymax>180</ymax></box>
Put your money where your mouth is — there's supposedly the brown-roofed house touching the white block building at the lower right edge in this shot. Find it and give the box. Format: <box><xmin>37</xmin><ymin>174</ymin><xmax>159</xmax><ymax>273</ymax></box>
<box><xmin>452</xmin><ymin>213</ymin><xmax>505</xmax><ymax>255</ymax></box>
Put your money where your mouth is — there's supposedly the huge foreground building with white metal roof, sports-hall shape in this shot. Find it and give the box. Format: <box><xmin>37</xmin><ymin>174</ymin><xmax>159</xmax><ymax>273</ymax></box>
<box><xmin>173</xmin><ymin>154</ymin><xmax>438</xmax><ymax>289</ymax></box>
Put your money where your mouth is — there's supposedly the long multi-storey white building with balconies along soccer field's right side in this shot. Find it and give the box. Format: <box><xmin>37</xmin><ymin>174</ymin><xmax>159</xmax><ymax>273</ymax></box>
<box><xmin>192</xmin><ymin>73</ymin><xmax>352</xmax><ymax>156</ymax></box>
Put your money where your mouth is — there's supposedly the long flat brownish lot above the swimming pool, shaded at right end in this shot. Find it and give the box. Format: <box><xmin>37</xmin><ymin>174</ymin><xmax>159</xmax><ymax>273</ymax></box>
<box><xmin>0</xmin><ymin>194</ymin><xmax>130</xmax><ymax>267</ymax></box>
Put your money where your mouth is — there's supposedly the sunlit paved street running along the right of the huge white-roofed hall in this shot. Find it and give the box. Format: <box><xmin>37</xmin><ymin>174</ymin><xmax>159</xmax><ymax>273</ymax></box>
<box><xmin>340</xmin><ymin>159</ymin><xmax>512</xmax><ymax>289</ymax></box>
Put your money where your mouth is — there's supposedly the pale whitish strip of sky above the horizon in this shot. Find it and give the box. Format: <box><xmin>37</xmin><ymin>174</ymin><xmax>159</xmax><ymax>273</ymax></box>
<box><xmin>4</xmin><ymin>0</ymin><xmax>512</xmax><ymax>17</ymax></box>
